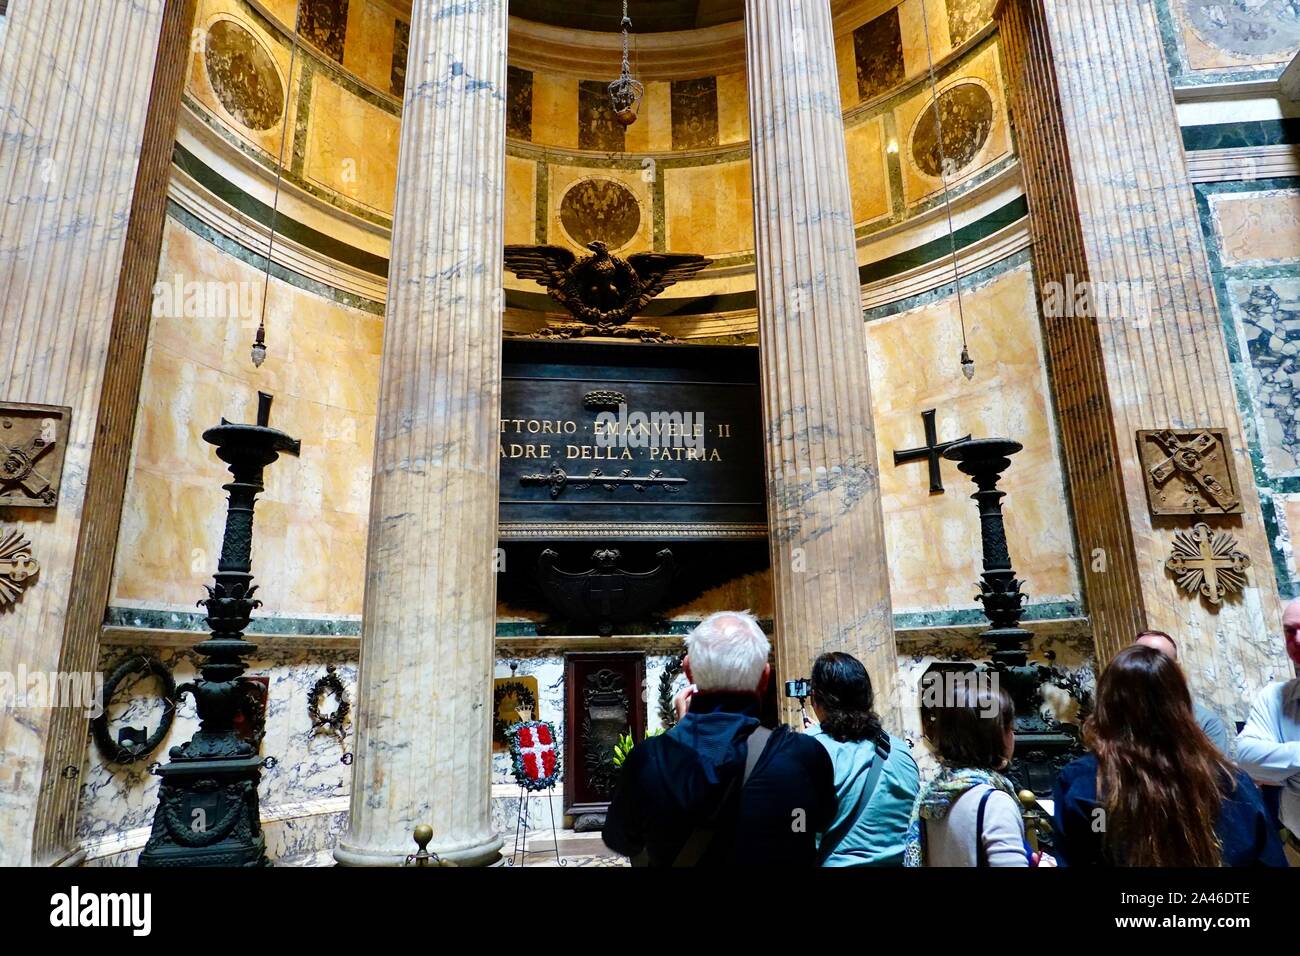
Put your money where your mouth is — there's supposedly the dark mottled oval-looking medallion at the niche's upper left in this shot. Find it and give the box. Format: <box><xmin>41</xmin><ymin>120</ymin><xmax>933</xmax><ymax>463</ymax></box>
<box><xmin>204</xmin><ymin>20</ymin><xmax>285</xmax><ymax>130</ymax></box>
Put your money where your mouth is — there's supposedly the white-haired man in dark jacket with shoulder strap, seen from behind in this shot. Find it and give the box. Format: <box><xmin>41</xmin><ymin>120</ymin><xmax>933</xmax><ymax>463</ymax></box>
<box><xmin>603</xmin><ymin>611</ymin><xmax>835</xmax><ymax>866</ymax></box>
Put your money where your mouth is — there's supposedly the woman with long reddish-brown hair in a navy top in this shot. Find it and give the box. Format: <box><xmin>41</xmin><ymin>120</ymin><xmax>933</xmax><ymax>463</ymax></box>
<box><xmin>1052</xmin><ymin>645</ymin><xmax>1287</xmax><ymax>866</ymax></box>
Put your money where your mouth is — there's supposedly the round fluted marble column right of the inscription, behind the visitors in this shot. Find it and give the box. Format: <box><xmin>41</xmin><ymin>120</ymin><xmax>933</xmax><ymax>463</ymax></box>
<box><xmin>745</xmin><ymin>0</ymin><xmax>900</xmax><ymax>728</ymax></box>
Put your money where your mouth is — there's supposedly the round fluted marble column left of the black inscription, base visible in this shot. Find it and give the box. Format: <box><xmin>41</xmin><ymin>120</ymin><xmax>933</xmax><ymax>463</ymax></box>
<box><xmin>335</xmin><ymin>0</ymin><xmax>507</xmax><ymax>866</ymax></box>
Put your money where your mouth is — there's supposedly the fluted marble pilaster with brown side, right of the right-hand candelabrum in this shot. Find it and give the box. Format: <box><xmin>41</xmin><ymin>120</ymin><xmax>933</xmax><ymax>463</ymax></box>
<box><xmin>997</xmin><ymin>0</ymin><xmax>1291</xmax><ymax>726</ymax></box>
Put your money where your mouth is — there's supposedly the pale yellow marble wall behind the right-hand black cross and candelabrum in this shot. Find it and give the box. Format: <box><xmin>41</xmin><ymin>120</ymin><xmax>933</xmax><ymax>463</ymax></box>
<box><xmin>867</xmin><ymin>264</ymin><xmax>1079</xmax><ymax>613</ymax></box>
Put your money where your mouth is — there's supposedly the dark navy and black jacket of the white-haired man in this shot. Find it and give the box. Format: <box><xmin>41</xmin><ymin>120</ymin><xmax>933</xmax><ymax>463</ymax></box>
<box><xmin>603</xmin><ymin>693</ymin><xmax>835</xmax><ymax>866</ymax></box>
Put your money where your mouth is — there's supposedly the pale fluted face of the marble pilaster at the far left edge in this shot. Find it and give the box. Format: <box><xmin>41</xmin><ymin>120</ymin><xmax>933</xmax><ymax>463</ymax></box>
<box><xmin>0</xmin><ymin>0</ymin><xmax>166</xmax><ymax>866</ymax></box>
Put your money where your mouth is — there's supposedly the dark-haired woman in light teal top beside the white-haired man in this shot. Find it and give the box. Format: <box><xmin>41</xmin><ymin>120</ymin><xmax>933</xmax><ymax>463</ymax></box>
<box><xmin>809</xmin><ymin>653</ymin><xmax>920</xmax><ymax>866</ymax></box>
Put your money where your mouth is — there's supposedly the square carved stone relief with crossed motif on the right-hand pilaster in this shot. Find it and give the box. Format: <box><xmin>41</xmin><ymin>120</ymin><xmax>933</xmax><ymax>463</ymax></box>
<box><xmin>1138</xmin><ymin>428</ymin><xmax>1243</xmax><ymax>516</ymax></box>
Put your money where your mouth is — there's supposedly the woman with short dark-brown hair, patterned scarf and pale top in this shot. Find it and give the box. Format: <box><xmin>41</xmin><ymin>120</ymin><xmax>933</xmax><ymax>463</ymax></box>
<box><xmin>904</xmin><ymin>672</ymin><xmax>1031</xmax><ymax>866</ymax></box>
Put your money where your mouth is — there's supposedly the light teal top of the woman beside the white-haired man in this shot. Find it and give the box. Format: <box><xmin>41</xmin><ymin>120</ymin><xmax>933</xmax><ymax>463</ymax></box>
<box><xmin>806</xmin><ymin>727</ymin><xmax>920</xmax><ymax>866</ymax></box>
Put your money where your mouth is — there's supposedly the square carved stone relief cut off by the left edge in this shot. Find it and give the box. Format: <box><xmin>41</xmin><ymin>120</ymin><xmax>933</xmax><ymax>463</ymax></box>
<box><xmin>0</xmin><ymin>403</ymin><xmax>73</xmax><ymax>507</ymax></box>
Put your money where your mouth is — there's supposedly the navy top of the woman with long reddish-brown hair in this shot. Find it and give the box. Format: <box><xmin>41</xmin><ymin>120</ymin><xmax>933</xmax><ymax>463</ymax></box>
<box><xmin>1052</xmin><ymin>753</ymin><xmax>1287</xmax><ymax>866</ymax></box>
